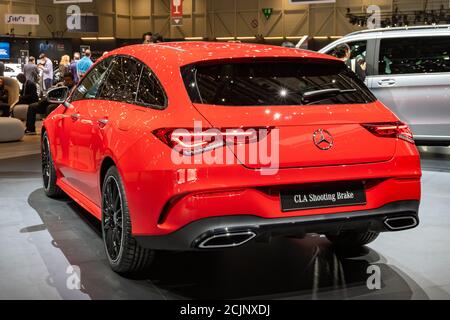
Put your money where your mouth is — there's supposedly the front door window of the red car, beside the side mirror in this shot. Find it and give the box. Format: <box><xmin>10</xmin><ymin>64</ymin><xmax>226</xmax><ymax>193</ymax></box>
<box><xmin>72</xmin><ymin>58</ymin><xmax>111</xmax><ymax>101</ymax></box>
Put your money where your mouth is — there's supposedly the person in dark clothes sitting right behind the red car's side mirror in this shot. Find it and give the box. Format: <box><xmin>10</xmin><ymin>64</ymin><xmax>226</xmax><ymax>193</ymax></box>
<box><xmin>25</xmin><ymin>72</ymin><xmax>75</xmax><ymax>135</ymax></box>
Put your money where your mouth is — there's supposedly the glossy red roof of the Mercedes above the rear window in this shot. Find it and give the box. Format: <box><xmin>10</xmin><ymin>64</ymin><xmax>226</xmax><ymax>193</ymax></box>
<box><xmin>104</xmin><ymin>41</ymin><xmax>339</xmax><ymax>66</ymax></box>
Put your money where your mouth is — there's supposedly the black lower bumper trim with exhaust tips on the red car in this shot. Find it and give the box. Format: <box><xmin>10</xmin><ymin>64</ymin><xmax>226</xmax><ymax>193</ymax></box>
<box><xmin>135</xmin><ymin>200</ymin><xmax>419</xmax><ymax>251</ymax></box>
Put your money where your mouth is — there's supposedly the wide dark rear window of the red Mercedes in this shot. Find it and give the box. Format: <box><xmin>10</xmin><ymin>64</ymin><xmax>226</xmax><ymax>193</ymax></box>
<box><xmin>181</xmin><ymin>61</ymin><xmax>376</xmax><ymax>106</ymax></box>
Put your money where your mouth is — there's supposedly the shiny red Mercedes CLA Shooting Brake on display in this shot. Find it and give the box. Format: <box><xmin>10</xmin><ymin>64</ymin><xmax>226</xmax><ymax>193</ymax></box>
<box><xmin>42</xmin><ymin>42</ymin><xmax>421</xmax><ymax>273</ymax></box>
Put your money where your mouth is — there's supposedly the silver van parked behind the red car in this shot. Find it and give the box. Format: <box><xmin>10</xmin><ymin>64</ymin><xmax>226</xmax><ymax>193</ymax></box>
<box><xmin>319</xmin><ymin>25</ymin><xmax>450</xmax><ymax>146</ymax></box>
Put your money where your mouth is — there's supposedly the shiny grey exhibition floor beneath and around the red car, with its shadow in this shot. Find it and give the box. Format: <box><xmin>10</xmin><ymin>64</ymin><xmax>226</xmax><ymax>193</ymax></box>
<box><xmin>0</xmin><ymin>141</ymin><xmax>450</xmax><ymax>299</ymax></box>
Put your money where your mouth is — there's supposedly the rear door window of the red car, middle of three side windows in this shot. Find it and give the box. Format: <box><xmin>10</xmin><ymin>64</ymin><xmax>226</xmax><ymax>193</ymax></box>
<box><xmin>99</xmin><ymin>57</ymin><xmax>143</xmax><ymax>103</ymax></box>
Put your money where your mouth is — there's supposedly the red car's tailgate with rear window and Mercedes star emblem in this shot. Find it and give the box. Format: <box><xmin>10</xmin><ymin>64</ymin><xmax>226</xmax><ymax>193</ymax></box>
<box><xmin>183</xmin><ymin>60</ymin><xmax>397</xmax><ymax>169</ymax></box>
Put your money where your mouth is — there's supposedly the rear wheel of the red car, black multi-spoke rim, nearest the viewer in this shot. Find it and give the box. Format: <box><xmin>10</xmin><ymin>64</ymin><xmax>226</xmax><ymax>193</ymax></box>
<box><xmin>102</xmin><ymin>166</ymin><xmax>154</xmax><ymax>275</ymax></box>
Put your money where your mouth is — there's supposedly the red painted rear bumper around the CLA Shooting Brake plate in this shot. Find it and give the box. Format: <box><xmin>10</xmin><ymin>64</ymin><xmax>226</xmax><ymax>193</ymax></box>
<box><xmin>119</xmin><ymin>138</ymin><xmax>421</xmax><ymax>237</ymax></box>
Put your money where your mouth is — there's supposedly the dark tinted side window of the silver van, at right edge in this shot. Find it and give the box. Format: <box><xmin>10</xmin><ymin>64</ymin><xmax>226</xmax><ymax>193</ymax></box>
<box><xmin>378</xmin><ymin>37</ymin><xmax>450</xmax><ymax>74</ymax></box>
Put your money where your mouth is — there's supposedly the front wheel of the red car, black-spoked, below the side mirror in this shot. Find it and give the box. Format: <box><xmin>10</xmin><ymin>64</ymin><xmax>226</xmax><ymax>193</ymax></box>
<box><xmin>41</xmin><ymin>132</ymin><xmax>64</xmax><ymax>198</ymax></box>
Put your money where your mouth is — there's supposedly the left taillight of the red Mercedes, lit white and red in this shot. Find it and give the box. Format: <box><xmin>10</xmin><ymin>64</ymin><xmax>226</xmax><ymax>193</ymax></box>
<box><xmin>153</xmin><ymin>127</ymin><xmax>272</xmax><ymax>155</ymax></box>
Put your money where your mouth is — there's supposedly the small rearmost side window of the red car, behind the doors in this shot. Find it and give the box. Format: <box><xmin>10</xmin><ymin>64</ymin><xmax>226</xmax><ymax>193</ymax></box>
<box><xmin>136</xmin><ymin>67</ymin><xmax>167</xmax><ymax>109</ymax></box>
